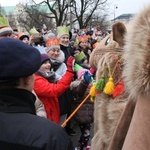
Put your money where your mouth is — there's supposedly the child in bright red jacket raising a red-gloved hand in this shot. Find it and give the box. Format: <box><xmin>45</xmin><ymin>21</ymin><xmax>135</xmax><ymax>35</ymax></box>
<box><xmin>34</xmin><ymin>55</ymin><xmax>74</xmax><ymax>124</ymax></box>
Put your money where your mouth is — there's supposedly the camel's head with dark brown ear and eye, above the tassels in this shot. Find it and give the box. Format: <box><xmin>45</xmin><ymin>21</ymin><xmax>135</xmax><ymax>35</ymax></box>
<box><xmin>89</xmin><ymin>22</ymin><xmax>127</xmax><ymax>69</ymax></box>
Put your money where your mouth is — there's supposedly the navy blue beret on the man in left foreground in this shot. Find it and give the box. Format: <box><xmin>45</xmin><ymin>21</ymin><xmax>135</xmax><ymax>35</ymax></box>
<box><xmin>0</xmin><ymin>37</ymin><xmax>41</xmax><ymax>80</ymax></box>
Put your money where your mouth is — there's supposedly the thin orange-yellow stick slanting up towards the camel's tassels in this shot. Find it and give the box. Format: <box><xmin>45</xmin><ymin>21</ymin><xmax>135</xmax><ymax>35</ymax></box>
<box><xmin>61</xmin><ymin>94</ymin><xmax>90</xmax><ymax>127</ymax></box>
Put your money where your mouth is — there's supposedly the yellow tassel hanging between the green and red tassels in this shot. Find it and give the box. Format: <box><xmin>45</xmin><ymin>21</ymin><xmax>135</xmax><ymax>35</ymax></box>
<box><xmin>104</xmin><ymin>77</ymin><xmax>115</xmax><ymax>95</ymax></box>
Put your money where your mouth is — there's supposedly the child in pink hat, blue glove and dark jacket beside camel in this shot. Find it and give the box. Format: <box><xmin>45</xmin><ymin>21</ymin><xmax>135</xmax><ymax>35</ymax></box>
<box><xmin>70</xmin><ymin>67</ymin><xmax>94</xmax><ymax>150</ymax></box>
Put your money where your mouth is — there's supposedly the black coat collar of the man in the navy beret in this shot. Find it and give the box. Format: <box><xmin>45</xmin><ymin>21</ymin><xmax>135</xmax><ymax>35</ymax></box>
<box><xmin>0</xmin><ymin>89</ymin><xmax>36</xmax><ymax>114</ymax></box>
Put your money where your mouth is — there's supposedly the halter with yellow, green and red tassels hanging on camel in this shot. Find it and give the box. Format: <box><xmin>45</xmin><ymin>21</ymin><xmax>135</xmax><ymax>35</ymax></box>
<box><xmin>90</xmin><ymin>53</ymin><xmax>124</xmax><ymax>101</ymax></box>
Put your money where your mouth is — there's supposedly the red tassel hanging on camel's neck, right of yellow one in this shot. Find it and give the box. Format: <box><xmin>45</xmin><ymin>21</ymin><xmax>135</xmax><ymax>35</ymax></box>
<box><xmin>113</xmin><ymin>81</ymin><xmax>124</xmax><ymax>98</ymax></box>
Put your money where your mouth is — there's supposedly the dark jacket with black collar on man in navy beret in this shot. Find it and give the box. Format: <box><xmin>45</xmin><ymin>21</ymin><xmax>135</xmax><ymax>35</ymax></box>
<box><xmin>0</xmin><ymin>89</ymin><xmax>74</xmax><ymax>150</ymax></box>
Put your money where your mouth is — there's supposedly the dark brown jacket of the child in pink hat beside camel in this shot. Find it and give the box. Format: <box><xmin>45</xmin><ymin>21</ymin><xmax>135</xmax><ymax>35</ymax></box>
<box><xmin>70</xmin><ymin>80</ymin><xmax>94</xmax><ymax>124</ymax></box>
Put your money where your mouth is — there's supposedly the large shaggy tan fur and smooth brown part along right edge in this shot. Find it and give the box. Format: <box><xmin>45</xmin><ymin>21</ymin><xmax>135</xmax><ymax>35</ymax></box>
<box><xmin>108</xmin><ymin>4</ymin><xmax>150</xmax><ymax>150</ymax></box>
